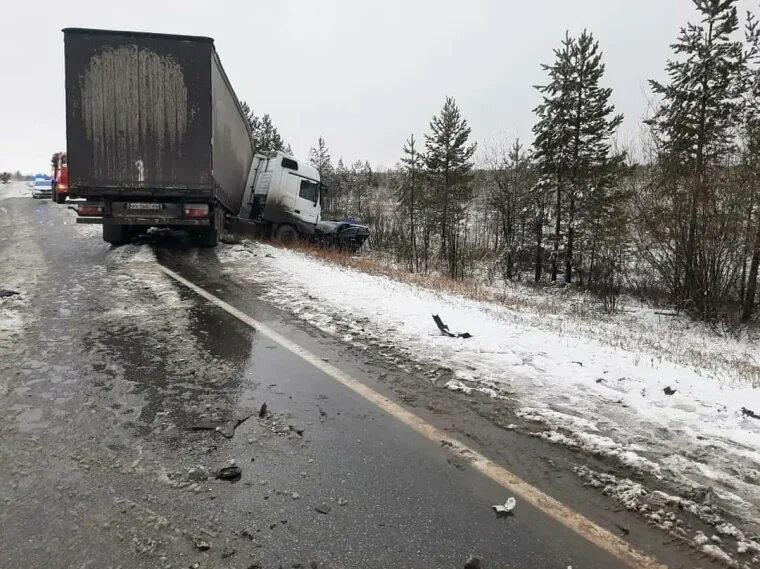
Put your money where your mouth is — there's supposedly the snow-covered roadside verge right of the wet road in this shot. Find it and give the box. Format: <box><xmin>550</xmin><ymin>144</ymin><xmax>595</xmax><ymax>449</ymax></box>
<box><xmin>217</xmin><ymin>241</ymin><xmax>760</xmax><ymax>532</ymax></box>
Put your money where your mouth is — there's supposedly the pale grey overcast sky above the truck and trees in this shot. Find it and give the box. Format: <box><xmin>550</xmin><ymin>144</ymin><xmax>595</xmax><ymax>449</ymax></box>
<box><xmin>0</xmin><ymin>0</ymin><xmax>756</xmax><ymax>172</ymax></box>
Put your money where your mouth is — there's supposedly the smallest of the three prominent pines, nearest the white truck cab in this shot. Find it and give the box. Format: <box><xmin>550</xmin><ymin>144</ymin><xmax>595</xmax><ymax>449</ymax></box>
<box><xmin>425</xmin><ymin>97</ymin><xmax>477</xmax><ymax>277</ymax></box>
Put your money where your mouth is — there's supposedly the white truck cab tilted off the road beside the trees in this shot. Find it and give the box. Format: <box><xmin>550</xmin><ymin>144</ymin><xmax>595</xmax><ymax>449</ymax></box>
<box><xmin>240</xmin><ymin>151</ymin><xmax>322</xmax><ymax>240</ymax></box>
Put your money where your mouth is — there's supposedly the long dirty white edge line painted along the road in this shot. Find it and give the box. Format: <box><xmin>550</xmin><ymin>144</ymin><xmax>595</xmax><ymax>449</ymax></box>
<box><xmin>159</xmin><ymin>265</ymin><xmax>667</xmax><ymax>569</ymax></box>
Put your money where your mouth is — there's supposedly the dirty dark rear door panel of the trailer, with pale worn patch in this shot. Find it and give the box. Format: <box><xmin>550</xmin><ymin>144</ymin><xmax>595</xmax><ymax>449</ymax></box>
<box><xmin>65</xmin><ymin>30</ymin><xmax>212</xmax><ymax>191</ymax></box>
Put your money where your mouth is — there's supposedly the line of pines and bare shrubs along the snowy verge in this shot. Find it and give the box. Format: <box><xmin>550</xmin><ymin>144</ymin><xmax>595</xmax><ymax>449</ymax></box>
<box><xmin>245</xmin><ymin>0</ymin><xmax>760</xmax><ymax>322</ymax></box>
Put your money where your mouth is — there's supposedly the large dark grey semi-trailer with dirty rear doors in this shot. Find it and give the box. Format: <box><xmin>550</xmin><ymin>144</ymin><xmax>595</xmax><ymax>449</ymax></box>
<box><xmin>63</xmin><ymin>28</ymin><xmax>253</xmax><ymax>246</ymax></box>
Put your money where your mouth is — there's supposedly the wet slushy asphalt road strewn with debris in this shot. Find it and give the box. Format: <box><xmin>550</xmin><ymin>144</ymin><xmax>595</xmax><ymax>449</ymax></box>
<box><xmin>0</xmin><ymin>190</ymin><xmax>711</xmax><ymax>569</ymax></box>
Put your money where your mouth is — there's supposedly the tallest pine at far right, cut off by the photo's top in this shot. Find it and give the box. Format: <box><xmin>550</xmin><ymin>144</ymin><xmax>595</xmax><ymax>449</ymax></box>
<box><xmin>648</xmin><ymin>0</ymin><xmax>744</xmax><ymax>316</ymax></box>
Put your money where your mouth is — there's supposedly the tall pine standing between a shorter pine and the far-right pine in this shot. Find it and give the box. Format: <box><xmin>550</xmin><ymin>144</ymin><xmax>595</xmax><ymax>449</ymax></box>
<box><xmin>533</xmin><ymin>31</ymin><xmax>623</xmax><ymax>283</ymax></box>
